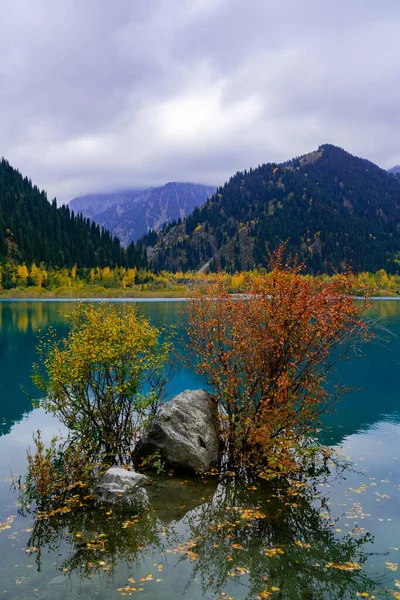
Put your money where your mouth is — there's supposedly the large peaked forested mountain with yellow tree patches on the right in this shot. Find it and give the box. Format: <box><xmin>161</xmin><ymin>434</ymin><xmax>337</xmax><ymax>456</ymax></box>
<box><xmin>144</xmin><ymin>144</ymin><xmax>400</xmax><ymax>274</ymax></box>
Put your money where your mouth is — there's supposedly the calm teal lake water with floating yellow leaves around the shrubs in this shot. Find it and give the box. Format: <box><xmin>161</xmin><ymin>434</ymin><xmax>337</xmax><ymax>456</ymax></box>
<box><xmin>0</xmin><ymin>301</ymin><xmax>400</xmax><ymax>600</ymax></box>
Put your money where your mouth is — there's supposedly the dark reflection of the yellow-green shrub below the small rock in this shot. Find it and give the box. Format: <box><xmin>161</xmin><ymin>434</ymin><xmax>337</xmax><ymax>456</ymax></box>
<box><xmin>19</xmin><ymin>492</ymin><xmax>173</xmax><ymax>578</ymax></box>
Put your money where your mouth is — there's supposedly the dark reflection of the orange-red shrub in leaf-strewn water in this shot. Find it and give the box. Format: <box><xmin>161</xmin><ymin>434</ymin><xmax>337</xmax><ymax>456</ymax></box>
<box><xmin>185</xmin><ymin>479</ymin><xmax>376</xmax><ymax>600</ymax></box>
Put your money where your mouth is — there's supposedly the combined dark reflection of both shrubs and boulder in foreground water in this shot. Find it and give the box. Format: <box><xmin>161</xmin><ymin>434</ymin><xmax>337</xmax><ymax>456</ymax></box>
<box><xmin>15</xmin><ymin>476</ymin><xmax>378</xmax><ymax>600</ymax></box>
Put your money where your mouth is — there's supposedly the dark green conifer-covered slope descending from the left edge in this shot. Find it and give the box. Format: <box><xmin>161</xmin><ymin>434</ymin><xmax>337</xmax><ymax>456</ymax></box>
<box><xmin>0</xmin><ymin>158</ymin><xmax>146</xmax><ymax>267</ymax></box>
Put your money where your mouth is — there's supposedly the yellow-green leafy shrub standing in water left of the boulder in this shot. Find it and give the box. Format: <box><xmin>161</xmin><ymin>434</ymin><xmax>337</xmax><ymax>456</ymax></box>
<box><xmin>32</xmin><ymin>303</ymin><xmax>171</xmax><ymax>463</ymax></box>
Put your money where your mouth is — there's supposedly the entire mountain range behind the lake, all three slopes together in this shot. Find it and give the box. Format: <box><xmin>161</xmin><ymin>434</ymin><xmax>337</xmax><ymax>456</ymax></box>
<box><xmin>0</xmin><ymin>144</ymin><xmax>400</xmax><ymax>274</ymax></box>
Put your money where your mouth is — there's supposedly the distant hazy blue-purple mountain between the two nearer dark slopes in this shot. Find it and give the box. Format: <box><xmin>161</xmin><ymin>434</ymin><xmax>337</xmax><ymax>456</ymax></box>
<box><xmin>68</xmin><ymin>182</ymin><xmax>217</xmax><ymax>246</ymax></box>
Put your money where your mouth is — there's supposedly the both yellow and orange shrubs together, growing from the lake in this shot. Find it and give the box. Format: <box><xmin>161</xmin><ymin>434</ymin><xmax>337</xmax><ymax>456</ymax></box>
<box><xmin>22</xmin><ymin>248</ymin><xmax>372</xmax><ymax>506</ymax></box>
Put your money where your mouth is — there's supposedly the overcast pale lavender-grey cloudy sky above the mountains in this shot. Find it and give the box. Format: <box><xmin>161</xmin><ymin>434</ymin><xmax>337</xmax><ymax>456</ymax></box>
<box><xmin>0</xmin><ymin>0</ymin><xmax>400</xmax><ymax>201</ymax></box>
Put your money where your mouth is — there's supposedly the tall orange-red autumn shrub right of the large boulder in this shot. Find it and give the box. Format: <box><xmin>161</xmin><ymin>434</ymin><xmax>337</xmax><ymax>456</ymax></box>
<box><xmin>187</xmin><ymin>248</ymin><xmax>371</xmax><ymax>470</ymax></box>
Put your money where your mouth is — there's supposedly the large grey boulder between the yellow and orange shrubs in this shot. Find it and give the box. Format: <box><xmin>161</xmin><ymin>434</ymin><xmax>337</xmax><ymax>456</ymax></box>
<box><xmin>135</xmin><ymin>390</ymin><xmax>219</xmax><ymax>472</ymax></box>
